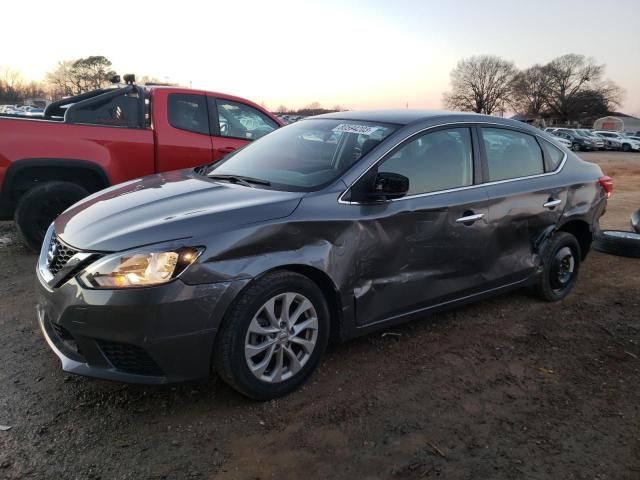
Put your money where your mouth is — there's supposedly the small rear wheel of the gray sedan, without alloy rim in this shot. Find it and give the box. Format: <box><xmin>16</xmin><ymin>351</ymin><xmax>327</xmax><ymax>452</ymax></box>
<box><xmin>534</xmin><ymin>232</ymin><xmax>582</xmax><ymax>302</ymax></box>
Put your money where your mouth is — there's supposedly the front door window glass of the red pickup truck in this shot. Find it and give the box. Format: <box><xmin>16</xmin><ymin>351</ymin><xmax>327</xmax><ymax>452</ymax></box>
<box><xmin>216</xmin><ymin>99</ymin><xmax>278</xmax><ymax>140</ymax></box>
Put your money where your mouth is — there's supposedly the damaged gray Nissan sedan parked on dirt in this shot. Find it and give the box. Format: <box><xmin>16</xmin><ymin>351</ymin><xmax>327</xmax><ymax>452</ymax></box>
<box><xmin>37</xmin><ymin>110</ymin><xmax>612</xmax><ymax>400</ymax></box>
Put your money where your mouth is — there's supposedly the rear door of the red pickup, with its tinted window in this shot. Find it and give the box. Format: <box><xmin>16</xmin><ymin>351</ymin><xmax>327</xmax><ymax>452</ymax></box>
<box><xmin>152</xmin><ymin>90</ymin><xmax>212</xmax><ymax>172</ymax></box>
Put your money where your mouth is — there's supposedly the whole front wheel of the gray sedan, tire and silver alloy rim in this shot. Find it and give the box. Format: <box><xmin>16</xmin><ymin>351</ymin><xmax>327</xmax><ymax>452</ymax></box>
<box><xmin>212</xmin><ymin>270</ymin><xmax>330</xmax><ymax>401</ymax></box>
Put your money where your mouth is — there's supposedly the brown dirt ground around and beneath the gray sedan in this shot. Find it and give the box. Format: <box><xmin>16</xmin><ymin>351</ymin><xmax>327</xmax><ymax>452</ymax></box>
<box><xmin>0</xmin><ymin>152</ymin><xmax>640</xmax><ymax>480</ymax></box>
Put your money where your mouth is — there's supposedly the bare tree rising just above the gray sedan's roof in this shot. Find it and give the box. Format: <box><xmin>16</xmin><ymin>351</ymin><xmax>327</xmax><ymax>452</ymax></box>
<box><xmin>444</xmin><ymin>55</ymin><xmax>517</xmax><ymax>115</ymax></box>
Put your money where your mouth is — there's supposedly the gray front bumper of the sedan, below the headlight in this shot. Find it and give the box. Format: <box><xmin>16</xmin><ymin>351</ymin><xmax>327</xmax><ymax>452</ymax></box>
<box><xmin>36</xmin><ymin>271</ymin><xmax>246</xmax><ymax>384</ymax></box>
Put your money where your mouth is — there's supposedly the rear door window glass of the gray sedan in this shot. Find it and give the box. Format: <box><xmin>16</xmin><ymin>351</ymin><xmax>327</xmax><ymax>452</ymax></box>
<box><xmin>481</xmin><ymin>128</ymin><xmax>544</xmax><ymax>182</ymax></box>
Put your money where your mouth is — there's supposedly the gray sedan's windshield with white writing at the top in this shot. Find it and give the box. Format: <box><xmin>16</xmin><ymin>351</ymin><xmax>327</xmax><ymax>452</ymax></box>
<box><xmin>207</xmin><ymin>119</ymin><xmax>398</xmax><ymax>191</ymax></box>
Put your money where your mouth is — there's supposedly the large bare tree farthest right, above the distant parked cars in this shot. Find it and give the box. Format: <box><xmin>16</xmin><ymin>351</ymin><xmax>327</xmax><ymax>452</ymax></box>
<box><xmin>544</xmin><ymin>53</ymin><xmax>623</xmax><ymax>121</ymax></box>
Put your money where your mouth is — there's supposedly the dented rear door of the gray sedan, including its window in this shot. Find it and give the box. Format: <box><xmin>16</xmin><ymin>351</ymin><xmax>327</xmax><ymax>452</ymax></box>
<box><xmin>479</xmin><ymin>126</ymin><xmax>567</xmax><ymax>285</ymax></box>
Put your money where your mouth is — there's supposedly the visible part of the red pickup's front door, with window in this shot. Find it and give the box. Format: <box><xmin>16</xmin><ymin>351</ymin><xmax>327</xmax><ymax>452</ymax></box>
<box><xmin>207</xmin><ymin>96</ymin><xmax>279</xmax><ymax>161</ymax></box>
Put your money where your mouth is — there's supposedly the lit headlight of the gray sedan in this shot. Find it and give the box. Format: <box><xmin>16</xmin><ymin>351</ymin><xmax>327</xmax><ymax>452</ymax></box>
<box><xmin>80</xmin><ymin>247</ymin><xmax>204</xmax><ymax>289</ymax></box>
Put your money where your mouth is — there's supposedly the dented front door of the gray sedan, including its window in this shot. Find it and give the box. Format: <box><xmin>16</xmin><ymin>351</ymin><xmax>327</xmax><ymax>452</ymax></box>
<box><xmin>349</xmin><ymin>126</ymin><xmax>491</xmax><ymax>325</ymax></box>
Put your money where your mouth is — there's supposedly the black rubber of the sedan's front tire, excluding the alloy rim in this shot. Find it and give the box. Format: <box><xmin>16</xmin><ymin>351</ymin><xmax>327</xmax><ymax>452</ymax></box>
<box><xmin>212</xmin><ymin>270</ymin><xmax>330</xmax><ymax>401</ymax></box>
